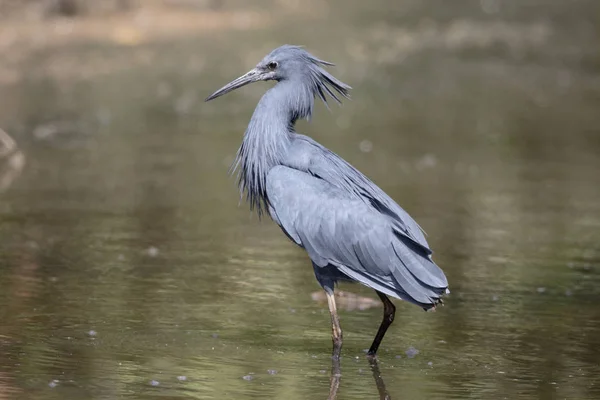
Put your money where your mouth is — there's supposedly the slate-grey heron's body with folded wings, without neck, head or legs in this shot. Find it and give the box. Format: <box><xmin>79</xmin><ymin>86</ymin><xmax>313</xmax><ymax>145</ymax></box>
<box><xmin>266</xmin><ymin>135</ymin><xmax>447</xmax><ymax>309</ymax></box>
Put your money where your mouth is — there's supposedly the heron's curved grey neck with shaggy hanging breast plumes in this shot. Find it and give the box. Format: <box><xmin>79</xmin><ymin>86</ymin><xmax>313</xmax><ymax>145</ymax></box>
<box><xmin>234</xmin><ymin>81</ymin><xmax>304</xmax><ymax>215</ymax></box>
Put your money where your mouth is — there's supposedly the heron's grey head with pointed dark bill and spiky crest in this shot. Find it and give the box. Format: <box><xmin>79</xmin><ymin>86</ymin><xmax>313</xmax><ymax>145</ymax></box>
<box><xmin>206</xmin><ymin>45</ymin><xmax>351</xmax><ymax>103</ymax></box>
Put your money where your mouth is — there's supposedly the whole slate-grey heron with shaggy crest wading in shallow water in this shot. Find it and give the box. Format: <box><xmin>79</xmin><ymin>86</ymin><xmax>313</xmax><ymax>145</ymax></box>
<box><xmin>206</xmin><ymin>45</ymin><xmax>448</xmax><ymax>358</ymax></box>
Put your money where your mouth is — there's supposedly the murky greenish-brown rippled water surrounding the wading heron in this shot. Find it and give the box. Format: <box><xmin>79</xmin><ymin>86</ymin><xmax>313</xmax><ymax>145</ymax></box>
<box><xmin>0</xmin><ymin>1</ymin><xmax>600</xmax><ymax>400</ymax></box>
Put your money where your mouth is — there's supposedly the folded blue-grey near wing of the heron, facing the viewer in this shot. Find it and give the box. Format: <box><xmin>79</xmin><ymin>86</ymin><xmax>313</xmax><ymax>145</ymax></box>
<box><xmin>267</xmin><ymin>166</ymin><xmax>448</xmax><ymax>306</ymax></box>
